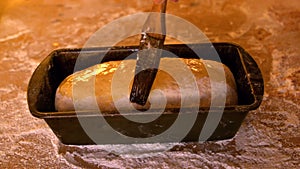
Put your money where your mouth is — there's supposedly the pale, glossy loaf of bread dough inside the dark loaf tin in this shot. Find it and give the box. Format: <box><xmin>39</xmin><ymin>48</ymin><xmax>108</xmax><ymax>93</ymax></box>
<box><xmin>55</xmin><ymin>58</ymin><xmax>238</xmax><ymax>113</ymax></box>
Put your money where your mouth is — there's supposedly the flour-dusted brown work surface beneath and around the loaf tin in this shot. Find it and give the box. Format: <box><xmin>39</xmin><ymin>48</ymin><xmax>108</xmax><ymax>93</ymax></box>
<box><xmin>0</xmin><ymin>0</ymin><xmax>300</xmax><ymax>168</ymax></box>
